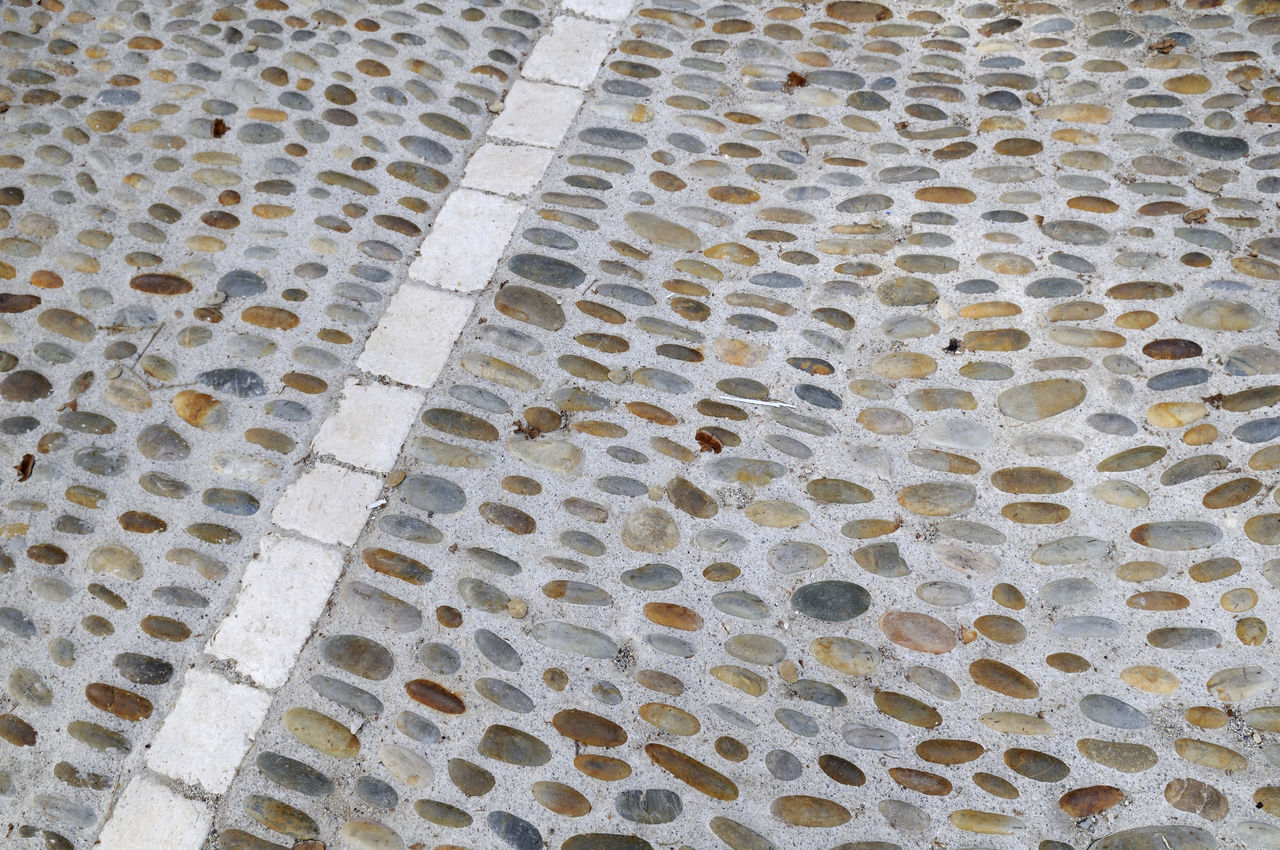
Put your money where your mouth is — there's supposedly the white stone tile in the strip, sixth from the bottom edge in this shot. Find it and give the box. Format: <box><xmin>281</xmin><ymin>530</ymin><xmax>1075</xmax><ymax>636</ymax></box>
<box><xmin>357</xmin><ymin>283</ymin><xmax>475</xmax><ymax>388</ymax></box>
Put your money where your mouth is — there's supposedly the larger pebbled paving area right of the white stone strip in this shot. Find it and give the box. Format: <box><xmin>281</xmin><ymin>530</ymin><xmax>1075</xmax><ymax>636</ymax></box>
<box><xmin>207</xmin><ymin>0</ymin><xmax>1280</xmax><ymax>850</ymax></box>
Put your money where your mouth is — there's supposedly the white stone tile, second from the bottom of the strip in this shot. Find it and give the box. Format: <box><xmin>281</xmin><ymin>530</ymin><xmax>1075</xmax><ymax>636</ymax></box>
<box><xmin>147</xmin><ymin>670</ymin><xmax>271</xmax><ymax>794</ymax></box>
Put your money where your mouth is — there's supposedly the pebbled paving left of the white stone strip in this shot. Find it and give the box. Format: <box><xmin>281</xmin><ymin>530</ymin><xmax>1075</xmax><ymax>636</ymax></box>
<box><xmin>0</xmin><ymin>0</ymin><xmax>547</xmax><ymax>850</ymax></box>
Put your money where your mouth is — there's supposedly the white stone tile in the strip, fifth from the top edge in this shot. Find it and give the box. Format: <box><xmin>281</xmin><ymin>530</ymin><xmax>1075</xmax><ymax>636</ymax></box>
<box><xmin>408</xmin><ymin>188</ymin><xmax>525</xmax><ymax>292</ymax></box>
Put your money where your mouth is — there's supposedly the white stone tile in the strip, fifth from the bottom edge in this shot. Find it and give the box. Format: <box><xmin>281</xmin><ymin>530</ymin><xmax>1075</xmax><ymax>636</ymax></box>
<box><xmin>311</xmin><ymin>379</ymin><xmax>424</xmax><ymax>472</ymax></box>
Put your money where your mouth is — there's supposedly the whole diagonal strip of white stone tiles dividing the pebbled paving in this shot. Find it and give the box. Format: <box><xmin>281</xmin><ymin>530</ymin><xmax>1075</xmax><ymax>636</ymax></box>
<box><xmin>95</xmin><ymin>0</ymin><xmax>632</xmax><ymax>850</ymax></box>
